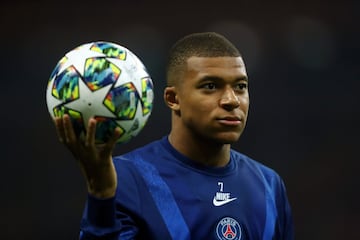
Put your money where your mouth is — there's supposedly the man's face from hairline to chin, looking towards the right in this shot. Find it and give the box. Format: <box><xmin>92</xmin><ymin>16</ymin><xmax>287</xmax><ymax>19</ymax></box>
<box><xmin>170</xmin><ymin>57</ymin><xmax>249</xmax><ymax>144</ymax></box>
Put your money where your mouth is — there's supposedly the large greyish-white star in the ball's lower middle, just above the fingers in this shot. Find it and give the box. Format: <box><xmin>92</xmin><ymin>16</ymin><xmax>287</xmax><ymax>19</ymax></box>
<box><xmin>64</xmin><ymin>78</ymin><xmax>115</xmax><ymax>126</ymax></box>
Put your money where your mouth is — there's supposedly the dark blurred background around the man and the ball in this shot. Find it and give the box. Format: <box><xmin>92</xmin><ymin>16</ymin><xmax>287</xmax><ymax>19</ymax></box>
<box><xmin>0</xmin><ymin>0</ymin><xmax>360</xmax><ymax>240</ymax></box>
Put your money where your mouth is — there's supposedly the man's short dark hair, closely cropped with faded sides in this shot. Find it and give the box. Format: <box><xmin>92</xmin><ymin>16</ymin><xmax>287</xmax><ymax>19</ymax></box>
<box><xmin>166</xmin><ymin>32</ymin><xmax>241</xmax><ymax>86</ymax></box>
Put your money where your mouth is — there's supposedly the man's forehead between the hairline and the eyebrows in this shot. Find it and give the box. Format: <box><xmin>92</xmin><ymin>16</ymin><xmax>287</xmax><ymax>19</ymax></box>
<box><xmin>187</xmin><ymin>57</ymin><xmax>247</xmax><ymax>78</ymax></box>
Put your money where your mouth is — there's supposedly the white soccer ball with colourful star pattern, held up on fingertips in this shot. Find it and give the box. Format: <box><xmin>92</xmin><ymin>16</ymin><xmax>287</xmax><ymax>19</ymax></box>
<box><xmin>46</xmin><ymin>41</ymin><xmax>154</xmax><ymax>143</ymax></box>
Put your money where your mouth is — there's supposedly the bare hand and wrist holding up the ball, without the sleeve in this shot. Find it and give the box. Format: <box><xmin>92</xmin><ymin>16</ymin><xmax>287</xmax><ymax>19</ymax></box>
<box><xmin>54</xmin><ymin>115</ymin><xmax>120</xmax><ymax>198</ymax></box>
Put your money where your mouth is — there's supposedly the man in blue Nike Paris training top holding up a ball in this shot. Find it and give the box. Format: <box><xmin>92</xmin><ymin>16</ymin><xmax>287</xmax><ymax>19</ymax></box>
<box><xmin>55</xmin><ymin>32</ymin><xmax>293</xmax><ymax>240</ymax></box>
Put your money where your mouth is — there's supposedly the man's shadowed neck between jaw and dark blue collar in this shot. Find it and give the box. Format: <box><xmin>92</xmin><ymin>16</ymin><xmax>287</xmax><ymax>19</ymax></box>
<box><xmin>169</xmin><ymin>131</ymin><xmax>230</xmax><ymax>167</ymax></box>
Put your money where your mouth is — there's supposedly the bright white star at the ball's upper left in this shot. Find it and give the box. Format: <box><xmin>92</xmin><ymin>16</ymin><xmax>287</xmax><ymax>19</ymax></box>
<box><xmin>59</xmin><ymin>43</ymin><xmax>105</xmax><ymax>75</ymax></box>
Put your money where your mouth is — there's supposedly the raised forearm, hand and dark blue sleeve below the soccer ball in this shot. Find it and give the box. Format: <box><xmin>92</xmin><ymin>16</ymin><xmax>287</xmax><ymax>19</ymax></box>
<box><xmin>54</xmin><ymin>115</ymin><xmax>136</xmax><ymax>240</ymax></box>
